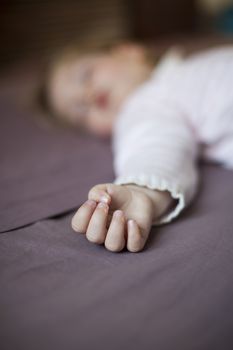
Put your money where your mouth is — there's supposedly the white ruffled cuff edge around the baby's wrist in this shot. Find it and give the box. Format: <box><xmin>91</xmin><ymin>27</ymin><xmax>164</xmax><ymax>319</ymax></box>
<box><xmin>113</xmin><ymin>174</ymin><xmax>187</xmax><ymax>225</ymax></box>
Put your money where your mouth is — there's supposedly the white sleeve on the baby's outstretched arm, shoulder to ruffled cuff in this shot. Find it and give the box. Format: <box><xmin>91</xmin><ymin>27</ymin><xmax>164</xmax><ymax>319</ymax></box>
<box><xmin>113</xmin><ymin>81</ymin><xmax>198</xmax><ymax>225</ymax></box>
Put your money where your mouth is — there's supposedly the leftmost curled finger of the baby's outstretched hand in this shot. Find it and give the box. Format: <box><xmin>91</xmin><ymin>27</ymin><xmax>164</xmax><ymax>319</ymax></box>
<box><xmin>71</xmin><ymin>200</ymin><xmax>97</xmax><ymax>233</ymax></box>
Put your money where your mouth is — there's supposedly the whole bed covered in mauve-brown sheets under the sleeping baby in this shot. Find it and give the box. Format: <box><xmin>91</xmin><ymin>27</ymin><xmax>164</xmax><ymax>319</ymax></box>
<box><xmin>0</xmin><ymin>38</ymin><xmax>233</xmax><ymax>350</ymax></box>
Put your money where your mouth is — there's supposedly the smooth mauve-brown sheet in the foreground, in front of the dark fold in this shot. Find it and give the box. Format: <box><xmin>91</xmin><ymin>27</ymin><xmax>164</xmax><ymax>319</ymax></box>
<box><xmin>0</xmin><ymin>166</ymin><xmax>233</xmax><ymax>350</ymax></box>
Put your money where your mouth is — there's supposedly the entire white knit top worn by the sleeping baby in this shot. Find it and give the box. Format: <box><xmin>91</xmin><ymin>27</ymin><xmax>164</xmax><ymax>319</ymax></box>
<box><xmin>113</xmin><ymin>46</ymin><xmax>233</xmax><ymax>225</ymax></box>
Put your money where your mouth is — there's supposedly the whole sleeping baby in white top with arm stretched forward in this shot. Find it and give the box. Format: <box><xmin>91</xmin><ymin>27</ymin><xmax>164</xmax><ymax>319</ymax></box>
<box><xmin>46</xmin><ymin>44</ymin><xmax>233</xmax><ymax>252</ymax></box>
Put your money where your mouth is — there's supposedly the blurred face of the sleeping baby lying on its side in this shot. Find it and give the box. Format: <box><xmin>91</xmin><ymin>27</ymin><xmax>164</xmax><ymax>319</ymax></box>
<box><xmin>48</xmin><ymin>46</ymin><xmax>152</xmax><ymax>136</ymax></box>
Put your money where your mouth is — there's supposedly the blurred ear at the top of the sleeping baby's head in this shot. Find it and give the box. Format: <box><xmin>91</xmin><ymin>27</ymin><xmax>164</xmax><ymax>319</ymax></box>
<box><xmin>111</xmin><ymin>42</ymin><xmax>146</xmax><ymax>62</ymax></box>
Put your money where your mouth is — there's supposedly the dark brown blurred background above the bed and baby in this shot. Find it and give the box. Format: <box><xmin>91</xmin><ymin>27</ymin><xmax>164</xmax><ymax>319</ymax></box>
<box><xmin>0</xmin><ymin>0</ymin><xmax>233</xmax><ymax>69</ymax></box>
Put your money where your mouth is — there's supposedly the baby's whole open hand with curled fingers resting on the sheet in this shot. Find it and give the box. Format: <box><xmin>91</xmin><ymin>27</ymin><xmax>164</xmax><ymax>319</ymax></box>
<box><xmin>72</xmin><ymin>183</ymin><xmax>173</xmax><ymax>252</ymax></box>
